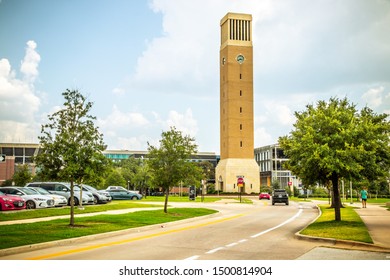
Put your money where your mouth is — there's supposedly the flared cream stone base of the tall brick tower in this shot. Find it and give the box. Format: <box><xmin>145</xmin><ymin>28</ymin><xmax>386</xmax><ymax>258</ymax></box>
<box><xmin>215</xmin><ymin>158</ymin><xmax>260</xmax><ymax>194</ymax></box>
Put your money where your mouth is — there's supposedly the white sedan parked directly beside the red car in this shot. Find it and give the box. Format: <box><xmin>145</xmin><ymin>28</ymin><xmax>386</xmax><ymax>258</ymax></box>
<box><xmin>0</xmin><ymin>187</ymin><xmax>54</xmax><ymax>209</ymax></box>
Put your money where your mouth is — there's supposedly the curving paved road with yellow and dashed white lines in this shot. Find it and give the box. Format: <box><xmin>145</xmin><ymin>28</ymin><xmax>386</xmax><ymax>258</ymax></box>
<box><xmin>2</xmin><ymin>200</ymin><xmax>389</xmax><ymax>260</ymax></box>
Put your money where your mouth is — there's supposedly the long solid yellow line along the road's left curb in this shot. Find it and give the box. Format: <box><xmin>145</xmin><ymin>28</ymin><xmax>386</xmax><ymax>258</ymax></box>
<box><xmin>27</xmin><ymin>211</ymin><xmax>247</xmax><ymax>260</ymax></box>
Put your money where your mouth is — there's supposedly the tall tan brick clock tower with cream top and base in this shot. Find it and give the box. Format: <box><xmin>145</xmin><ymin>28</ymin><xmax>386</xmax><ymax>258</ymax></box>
<box><xmin>215</xmin><ymin>13</ymin><xmax>260</xmax><ymax>193</ymax></box>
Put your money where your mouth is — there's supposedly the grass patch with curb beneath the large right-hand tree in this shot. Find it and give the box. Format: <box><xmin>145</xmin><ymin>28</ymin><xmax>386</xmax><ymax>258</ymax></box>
<box><xmin>300</xmin><ymin>205</ymin><xmax>373</xmax><ymax>243</ymax></box>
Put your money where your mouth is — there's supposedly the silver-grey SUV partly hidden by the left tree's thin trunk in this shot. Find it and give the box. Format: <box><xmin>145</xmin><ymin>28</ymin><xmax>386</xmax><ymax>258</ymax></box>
<box><xmin>26</xmin><ymin>182</ymin><xmax>94</xmax><ymax>205</ymax></box>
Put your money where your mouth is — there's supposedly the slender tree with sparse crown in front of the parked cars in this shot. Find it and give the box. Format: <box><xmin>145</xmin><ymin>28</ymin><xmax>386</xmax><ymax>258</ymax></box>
<box><xmin>36</xmin><ymin>90</ymin><xmax>107</xmax><ymax>226</ymax></box>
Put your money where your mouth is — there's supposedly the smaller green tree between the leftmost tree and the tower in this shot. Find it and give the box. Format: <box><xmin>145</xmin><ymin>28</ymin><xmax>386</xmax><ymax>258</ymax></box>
<box><xmin>148</xmin><ymin>127</ymin><xmax>201</xmax><ymax>213</ymax></box>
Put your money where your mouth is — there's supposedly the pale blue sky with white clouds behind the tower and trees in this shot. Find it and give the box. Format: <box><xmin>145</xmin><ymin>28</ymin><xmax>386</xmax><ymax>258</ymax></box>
<box><xmin>0</xmin><ymin>0</ymin><xmax>390</xmax><ymax>154</ymax></box>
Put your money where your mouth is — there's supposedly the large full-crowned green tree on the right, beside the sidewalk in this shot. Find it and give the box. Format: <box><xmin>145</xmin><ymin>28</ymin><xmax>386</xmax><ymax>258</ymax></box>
<box><xmin>279</xmin><ymin>98</ymin><xmax>390</xmax><ymax>221</ymax></box>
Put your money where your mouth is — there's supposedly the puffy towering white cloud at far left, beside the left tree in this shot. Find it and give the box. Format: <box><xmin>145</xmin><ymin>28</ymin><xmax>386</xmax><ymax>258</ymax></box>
<box><xmin>0</xmin><ymin>41</ymin><xmax>41</xmax><ymax>142</ymax></box>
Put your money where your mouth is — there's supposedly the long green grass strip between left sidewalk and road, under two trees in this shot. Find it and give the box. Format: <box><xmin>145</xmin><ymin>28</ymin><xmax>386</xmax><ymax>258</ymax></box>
<box><xmin>0</xmin><ymin>208</ymin><xmax>217</xmax><ymax>249</ymax></box>
